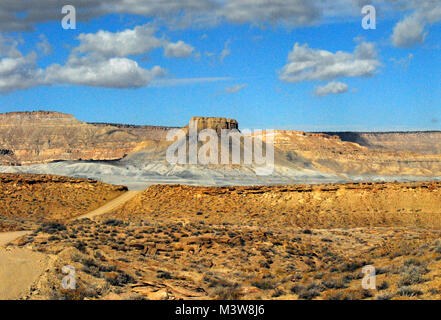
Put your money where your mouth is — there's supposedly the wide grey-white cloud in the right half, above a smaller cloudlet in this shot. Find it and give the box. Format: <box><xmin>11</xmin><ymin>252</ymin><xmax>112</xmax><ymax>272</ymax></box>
<box><xmin>279</xmin><ymin>42</ymin><xmax>381</xmax><ymax>82</ymax></box>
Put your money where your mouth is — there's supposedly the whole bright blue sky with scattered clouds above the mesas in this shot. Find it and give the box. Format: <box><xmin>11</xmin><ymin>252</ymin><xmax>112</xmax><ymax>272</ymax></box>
<box><xmin>0</xmin><ymin>0</ymin><xmax>441</xmax><ymax>131</ymax></box>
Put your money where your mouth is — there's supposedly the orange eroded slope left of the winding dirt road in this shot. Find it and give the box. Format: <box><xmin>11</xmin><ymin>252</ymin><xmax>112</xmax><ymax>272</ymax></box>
<box><xmin>0</xmin><ymin>174</ymin><xmax>127</xmax><ymax>232</ymax></box>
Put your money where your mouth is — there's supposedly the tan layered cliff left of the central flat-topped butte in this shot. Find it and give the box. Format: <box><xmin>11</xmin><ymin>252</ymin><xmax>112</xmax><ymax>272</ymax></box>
<box><xmin>0</xmin><ymin>111</ymin><xmax>172</xmax><ymax>165</ymax></box>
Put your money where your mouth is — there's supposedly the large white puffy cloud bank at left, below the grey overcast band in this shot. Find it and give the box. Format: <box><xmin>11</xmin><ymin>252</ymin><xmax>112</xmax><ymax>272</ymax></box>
<box><xmin>0</xmin><ymin>25</ymin><xmax>200</xmax><ymax>93</ymax></box>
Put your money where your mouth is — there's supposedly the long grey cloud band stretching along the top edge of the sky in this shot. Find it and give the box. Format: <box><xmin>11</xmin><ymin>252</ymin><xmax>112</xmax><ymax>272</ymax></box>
<box><xmin>0</xmin><ymin>0</ymin><xmax>359</xmax><ymax>31</ymax></box>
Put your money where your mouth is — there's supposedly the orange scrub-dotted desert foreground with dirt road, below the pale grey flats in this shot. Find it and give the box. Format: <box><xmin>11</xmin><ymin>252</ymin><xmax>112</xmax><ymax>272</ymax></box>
<box><xmin>0</xmin><ymin>174</ymin><xmax>441</xmax><ymax>300</ymax></box>
